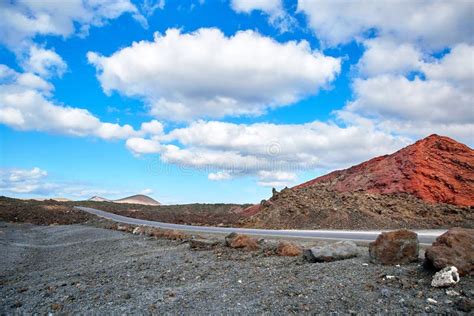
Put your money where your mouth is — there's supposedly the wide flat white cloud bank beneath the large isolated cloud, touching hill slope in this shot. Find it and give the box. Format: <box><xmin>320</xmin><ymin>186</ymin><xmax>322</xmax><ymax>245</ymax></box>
<box><xmin>123</xmin><ymin>121</ymin><xmax>407</xmax><ymax>186</ymax></box>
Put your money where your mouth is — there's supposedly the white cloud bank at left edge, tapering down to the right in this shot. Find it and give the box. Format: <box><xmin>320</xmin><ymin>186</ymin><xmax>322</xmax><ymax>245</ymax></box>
<box><xmin>0</xmin><ymin>65</ymin><xmax>139</xmax><ymax>139</ymax></box>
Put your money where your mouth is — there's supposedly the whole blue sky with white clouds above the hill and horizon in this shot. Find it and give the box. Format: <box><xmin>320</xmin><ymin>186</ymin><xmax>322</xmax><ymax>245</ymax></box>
<box><xmin>0</xmin><ymin>0</ymin><xmax>474</xmax><ymax>203</ymax></box>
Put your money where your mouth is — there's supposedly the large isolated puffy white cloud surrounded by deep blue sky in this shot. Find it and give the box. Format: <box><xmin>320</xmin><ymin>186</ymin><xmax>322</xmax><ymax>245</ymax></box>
<box><xmin>88</xmin><ymin>28</ymin><xmax>341</xmax><ymax>120</ymax></box>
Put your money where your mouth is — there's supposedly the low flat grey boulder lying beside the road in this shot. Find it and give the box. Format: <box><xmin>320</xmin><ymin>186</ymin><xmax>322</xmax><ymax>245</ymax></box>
<box><xmin>303</xmin><ymin>241</ymin><xmax>359</xmax><ymax>262</ymax></box>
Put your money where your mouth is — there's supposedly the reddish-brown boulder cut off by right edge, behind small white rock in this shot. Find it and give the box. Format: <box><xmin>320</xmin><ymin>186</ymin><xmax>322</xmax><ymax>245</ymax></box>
<box><xmin>425</xmin><ymin>228</ymin><xmax>474</xmax><ymax>276</ymax></box>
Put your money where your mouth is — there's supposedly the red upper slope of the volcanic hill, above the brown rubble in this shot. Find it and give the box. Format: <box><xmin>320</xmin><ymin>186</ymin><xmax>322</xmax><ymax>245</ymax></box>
<box><xmin>292</xmin><ymin>135</ymin><xmax>474</xmax><ymax>206</ymax></box>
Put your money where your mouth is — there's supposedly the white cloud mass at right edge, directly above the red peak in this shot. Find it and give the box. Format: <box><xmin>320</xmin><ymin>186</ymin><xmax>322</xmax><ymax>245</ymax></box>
<box><xmin>338</xmin><ymin>44</ymin><xmax>474</xmax><ymax>144</ymax></box>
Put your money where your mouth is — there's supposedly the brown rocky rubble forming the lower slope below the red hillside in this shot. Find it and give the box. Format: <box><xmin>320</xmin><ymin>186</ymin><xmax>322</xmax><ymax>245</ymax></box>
<box><xmin>242</xmin><ymin>184</ymin><xmax>474</xmax><ymax>229</ymax></box>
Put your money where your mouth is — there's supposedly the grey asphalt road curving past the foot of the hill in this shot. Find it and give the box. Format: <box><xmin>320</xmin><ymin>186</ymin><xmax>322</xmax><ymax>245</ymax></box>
<box><xmin>75</xmin><ymin>206</ymin><xmax>446</xmax><ymax>245</ymax></box>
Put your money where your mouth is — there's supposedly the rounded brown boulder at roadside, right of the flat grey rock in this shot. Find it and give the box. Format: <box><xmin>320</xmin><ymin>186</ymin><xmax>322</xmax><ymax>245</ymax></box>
<box><xmin>369</xmin><ymin>229</ymin><xmax>419</xmax><ymax>265</ymax></box>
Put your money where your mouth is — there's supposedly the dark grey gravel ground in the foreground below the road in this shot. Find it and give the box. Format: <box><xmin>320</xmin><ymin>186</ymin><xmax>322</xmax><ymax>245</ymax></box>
<box><xmin>0</xmin><ymin>222</ymin><xmax>474</xmax><ymax>314</ymax></box>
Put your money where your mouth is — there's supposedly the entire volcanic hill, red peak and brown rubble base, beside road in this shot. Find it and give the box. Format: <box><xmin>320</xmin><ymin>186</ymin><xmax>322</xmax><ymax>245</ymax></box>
<box><xmin>244</xmin><ymin>135</ymin><xmax>474</xmax><ymax>229</ymax></box>
